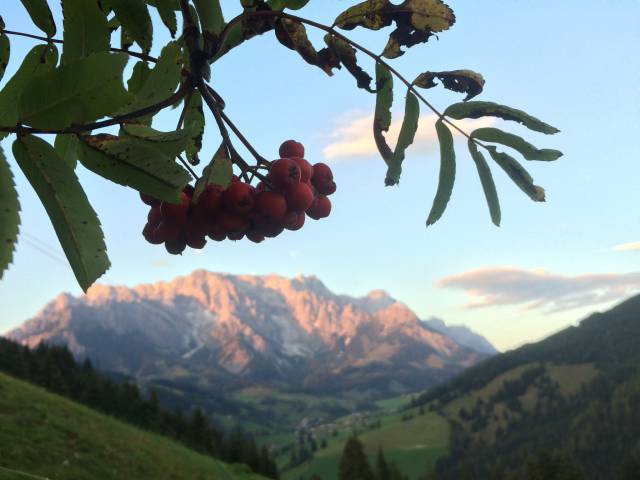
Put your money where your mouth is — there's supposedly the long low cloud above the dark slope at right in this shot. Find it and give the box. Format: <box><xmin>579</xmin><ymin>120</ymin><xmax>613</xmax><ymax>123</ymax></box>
<box><xmin>438</xmin><ymin>267</ymin><xmax>640</xmax><ymax>313</ymax></box>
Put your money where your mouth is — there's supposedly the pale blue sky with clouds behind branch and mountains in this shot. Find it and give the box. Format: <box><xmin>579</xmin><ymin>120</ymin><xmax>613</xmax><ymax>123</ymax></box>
<box><xmin>0</xmin><ymin>0</ymin><xmax>640</xmax><ymax>350</ymax></box>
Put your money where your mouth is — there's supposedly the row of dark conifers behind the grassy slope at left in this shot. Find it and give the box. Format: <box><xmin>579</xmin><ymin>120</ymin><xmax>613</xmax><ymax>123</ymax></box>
<box><xmin>0</xmin><ymin>338</ymin><xmax>279</xmax><ymax>479</ymax></box>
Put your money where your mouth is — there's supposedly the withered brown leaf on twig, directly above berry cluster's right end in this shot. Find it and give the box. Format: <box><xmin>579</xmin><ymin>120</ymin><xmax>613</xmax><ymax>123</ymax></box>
<box><xmin>275</xmin><ymin>18</ymin><xmax>340</xmax><ymax>75</ymax></box>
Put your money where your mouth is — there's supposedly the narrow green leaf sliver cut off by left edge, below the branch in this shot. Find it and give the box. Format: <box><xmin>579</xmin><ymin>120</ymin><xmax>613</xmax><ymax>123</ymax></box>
<box><xmin>0</xmin><ymin>148</ymin><xmax>20</xmax><ymax>279</ymax></box>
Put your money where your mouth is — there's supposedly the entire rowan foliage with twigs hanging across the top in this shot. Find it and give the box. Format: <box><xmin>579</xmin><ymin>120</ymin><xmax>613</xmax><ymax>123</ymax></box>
<box><xmin>0</xmin><ymin>0</ymin><xmax>561</xmax><ymax>290</ymax></box>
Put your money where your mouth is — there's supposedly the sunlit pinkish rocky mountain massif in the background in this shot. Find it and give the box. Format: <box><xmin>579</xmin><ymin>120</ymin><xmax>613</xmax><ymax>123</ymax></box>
<box><xmin>8</xmin><ymin>270</ymin><xmax>496</xmax><ymax>395</ymax></box>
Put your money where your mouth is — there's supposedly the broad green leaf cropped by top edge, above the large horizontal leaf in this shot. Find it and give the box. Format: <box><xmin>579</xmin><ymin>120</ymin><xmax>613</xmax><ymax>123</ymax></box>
<box><xmin>62</xmin><ymin>0</ymin><xmax>109</xmax><ymax>64</ymax></box>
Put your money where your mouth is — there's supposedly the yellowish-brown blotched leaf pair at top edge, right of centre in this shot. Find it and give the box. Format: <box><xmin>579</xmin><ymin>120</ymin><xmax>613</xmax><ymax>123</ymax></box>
<box><xmin>334</xmin><ymin>0</ymin><xmax>456</xmax><ymax>58</ymax></box>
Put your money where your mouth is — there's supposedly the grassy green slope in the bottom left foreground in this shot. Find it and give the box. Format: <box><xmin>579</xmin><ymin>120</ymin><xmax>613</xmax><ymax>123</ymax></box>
<box><xmin>0</xmin><ymin>374</ymin><xmax>262</xmax><ymax>480</ymax></box>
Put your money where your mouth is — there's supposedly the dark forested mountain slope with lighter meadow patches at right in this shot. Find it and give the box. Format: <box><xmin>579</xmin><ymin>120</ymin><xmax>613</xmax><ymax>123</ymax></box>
<box><xmin>416</xmin><ymin>296</ymin><xmax>640</xmax><ymax>480</ymax></box>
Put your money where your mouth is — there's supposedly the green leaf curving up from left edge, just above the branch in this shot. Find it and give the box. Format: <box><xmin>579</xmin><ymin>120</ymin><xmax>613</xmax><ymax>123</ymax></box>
<box><xmin>0</xmin><ymin>44</ymin><xmax>58</xmax><ymax>127</ymax></box>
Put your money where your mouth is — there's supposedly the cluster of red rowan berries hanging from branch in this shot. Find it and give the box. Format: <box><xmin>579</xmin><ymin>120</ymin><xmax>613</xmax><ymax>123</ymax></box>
<box><xmin>140</xmin><ymin>140</ymin><xmax>336</xmax><ymax>255</ymax></box>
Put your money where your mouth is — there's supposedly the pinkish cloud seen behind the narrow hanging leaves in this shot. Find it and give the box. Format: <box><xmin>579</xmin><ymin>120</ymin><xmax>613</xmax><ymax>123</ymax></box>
<box><xmin>323</xmin><ymin>113</ymin><xmax>495</xmax><ymax>162</ymax></box>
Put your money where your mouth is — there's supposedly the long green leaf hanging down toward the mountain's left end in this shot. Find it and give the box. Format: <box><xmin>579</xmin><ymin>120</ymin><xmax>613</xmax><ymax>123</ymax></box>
<box><xmin>13</xmin><ymin>135</ymin><xmax>110</xmax><ymax>292</ymax></box>
